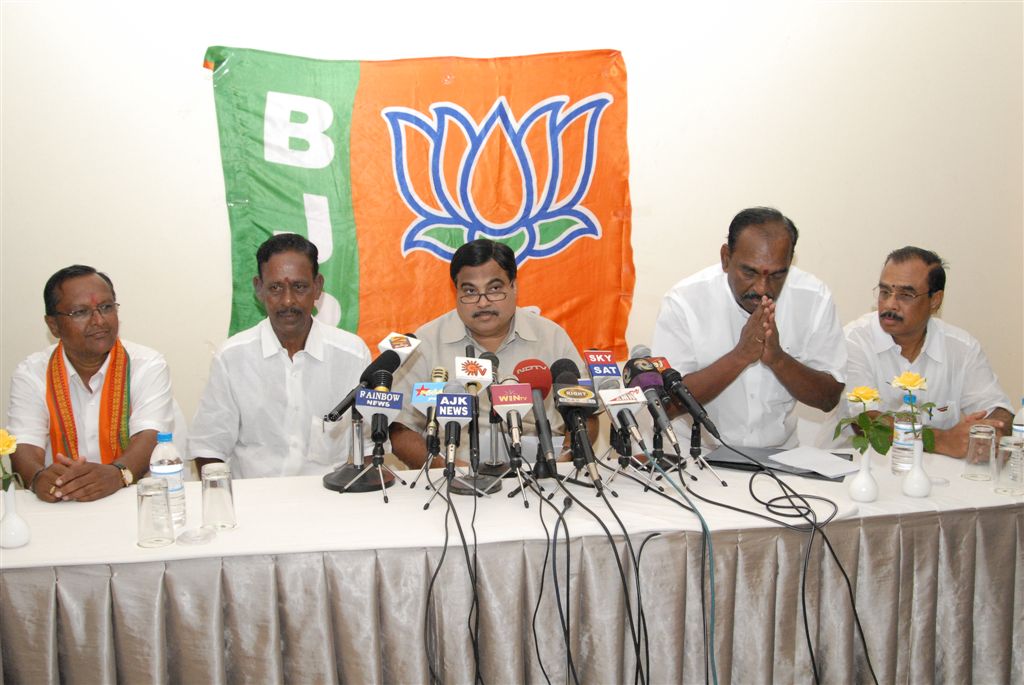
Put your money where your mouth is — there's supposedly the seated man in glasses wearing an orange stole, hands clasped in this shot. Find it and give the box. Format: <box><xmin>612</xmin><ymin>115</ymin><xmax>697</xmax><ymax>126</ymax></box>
<box><xmin>7</xmin><ymin>264</ymin><xmax>174</xmax><ymax>502</ymax></box>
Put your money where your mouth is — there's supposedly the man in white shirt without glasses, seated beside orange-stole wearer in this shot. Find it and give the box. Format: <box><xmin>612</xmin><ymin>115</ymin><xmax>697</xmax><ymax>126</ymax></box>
<box><xmin>188</xmin><ymin>233</ymin><xmax>370</xmax><ymax>478</ymax></box>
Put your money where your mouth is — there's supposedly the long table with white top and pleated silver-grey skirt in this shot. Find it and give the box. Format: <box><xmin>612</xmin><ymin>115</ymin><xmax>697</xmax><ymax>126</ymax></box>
<box><xmin>0</xmin><ymin>448</ymin><xmax>1024</xmax><ymax>683</ymax></box>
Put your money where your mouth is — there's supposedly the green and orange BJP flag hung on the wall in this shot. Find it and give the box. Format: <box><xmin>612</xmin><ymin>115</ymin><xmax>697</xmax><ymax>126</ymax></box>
<box><xmin>205</xmin><ymin>47</ymin><xmax>635</xmax><ymax>358</ymax></box>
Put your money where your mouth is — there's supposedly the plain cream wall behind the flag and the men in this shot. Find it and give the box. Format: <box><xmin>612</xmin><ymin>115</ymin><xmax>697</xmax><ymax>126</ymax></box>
<box><xmin>0</xmin><ymin>0</ymin><xmax>1024</xmax><ymax>416</ymax></box>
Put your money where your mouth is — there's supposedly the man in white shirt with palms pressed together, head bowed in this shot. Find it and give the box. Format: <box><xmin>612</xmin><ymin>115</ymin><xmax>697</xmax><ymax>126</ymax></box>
<box><xmin>651</xmin><ymin>207</ymin><xmax>846</xmax><ymax>447</ymax></box>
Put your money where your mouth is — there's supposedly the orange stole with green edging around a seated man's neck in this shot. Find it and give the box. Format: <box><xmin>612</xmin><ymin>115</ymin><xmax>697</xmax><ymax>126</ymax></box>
<box><xmin>46</xmin><ymin>339</ymin><xmax>131</xmax><ymax>464</ymax></box>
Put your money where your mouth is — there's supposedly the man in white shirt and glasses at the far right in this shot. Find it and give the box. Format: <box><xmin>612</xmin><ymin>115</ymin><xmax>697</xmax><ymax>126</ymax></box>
<box><xmin>844</xmin><ymin>246</ymin><xmax>1013</xmax><ymax>457</ymax></box>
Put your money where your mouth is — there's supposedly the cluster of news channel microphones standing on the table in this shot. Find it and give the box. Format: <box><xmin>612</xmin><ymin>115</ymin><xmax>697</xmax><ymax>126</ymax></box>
<box><xmin>324</xmin><ymin>333</ymin><xmax>719</xmax><ymax>501</ymax></box>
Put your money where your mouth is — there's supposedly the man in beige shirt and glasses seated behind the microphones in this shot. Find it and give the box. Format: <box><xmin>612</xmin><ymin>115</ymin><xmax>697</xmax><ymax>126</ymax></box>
<box><xmin>391</xmin><ymin>239</ymin><xmax>594</xmax><ymax>468</ymax></box>
